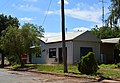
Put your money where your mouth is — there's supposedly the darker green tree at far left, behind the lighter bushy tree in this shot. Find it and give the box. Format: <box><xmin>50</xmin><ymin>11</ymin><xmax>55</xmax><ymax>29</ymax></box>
<box><xmin>0</xmin><ymin>14</ymin><xmax>19</xmax><ymax>67</ymax></box>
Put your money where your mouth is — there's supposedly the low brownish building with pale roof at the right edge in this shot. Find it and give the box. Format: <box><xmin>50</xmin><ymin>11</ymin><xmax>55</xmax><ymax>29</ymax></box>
<box><xmin>101</xmin><ymin>38</ymin><xmax>120</xmax><ymax>63</ymax></box>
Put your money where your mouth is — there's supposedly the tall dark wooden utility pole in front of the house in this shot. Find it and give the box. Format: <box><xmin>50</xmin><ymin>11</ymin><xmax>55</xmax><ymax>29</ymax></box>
<box><xmin>61</xmin><ymin>0</ymin><xmax>68</xmax><ymax>73</ymax></box>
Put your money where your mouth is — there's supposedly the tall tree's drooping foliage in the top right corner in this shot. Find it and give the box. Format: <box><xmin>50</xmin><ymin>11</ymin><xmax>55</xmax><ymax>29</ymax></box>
<box><xmin>108</xmin><ymin>0</ymin><xmax>120</xmax><ymax>27</ymax></box>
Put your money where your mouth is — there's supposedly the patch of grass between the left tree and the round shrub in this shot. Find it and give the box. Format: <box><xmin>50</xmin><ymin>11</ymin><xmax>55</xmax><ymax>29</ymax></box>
<box><xmin>26</xmin><ymin>64</ymin><xmax>79</xmax><ymax>73</ymax></box>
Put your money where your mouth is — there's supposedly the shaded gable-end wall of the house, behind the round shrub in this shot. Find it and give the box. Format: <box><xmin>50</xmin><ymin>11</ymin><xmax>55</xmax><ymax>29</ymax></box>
<box><xmin>73</xmin><ymin>32</ymin><xmax>101</xmax><ymax>63</ymax></box>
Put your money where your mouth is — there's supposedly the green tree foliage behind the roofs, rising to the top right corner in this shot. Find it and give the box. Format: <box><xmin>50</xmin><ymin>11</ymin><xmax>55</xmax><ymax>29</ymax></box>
<box><xmin>91</xmin><ymin>0</ymin><xmax>120</xmax><ymax>39</ymax></box>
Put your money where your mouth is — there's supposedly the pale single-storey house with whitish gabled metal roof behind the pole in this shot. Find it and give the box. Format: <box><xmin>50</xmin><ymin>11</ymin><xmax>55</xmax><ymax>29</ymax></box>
<box><xmin>31</xmin><ymin>31</ymin><xmax>101</xmax><ymax>64</ymax></box>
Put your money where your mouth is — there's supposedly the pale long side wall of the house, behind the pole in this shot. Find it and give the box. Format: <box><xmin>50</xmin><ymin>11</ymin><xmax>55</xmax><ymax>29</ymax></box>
<box><xmin>32</xmin><ymin>41</ymin><xmax>73</xmax><ymax>64</ymax></box>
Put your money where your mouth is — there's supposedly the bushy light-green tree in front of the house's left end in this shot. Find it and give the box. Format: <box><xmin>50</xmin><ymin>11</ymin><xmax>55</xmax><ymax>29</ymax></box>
<box><xmin>1</xmin><ymin>23</ymin><xmax>44</xmax><ymax>67</ymax></box>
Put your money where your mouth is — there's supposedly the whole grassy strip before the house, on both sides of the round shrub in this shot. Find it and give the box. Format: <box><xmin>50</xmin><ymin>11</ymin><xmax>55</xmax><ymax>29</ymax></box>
<box><xmin>12</xmin><ymin>64</ymin><xmax>120</xmax><ymax>78</ymax></box>
